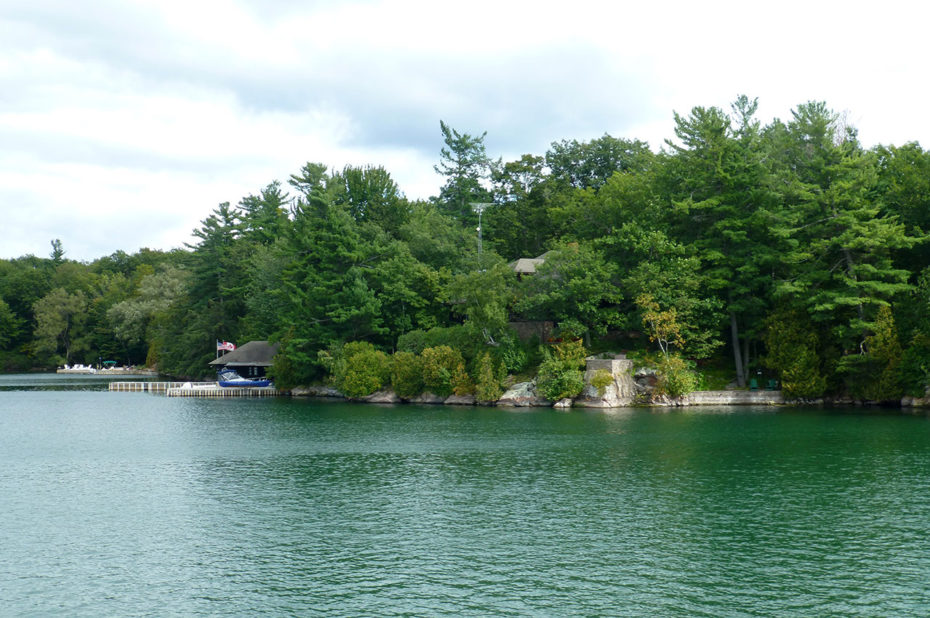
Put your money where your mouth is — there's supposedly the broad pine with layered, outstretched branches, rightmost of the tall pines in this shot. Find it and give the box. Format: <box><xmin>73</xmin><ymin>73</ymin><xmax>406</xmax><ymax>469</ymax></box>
<box><xmin>779</xmin><ymin>103</ymin><xmax>920</xmax><ymax>351</ymax></box>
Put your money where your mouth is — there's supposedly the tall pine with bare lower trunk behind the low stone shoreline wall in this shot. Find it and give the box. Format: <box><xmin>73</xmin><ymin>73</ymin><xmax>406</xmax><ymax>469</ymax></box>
<box><xmin>666</xmin><ymin>95</ymin><xmax>783</xmax><ymax>386</ymax></box>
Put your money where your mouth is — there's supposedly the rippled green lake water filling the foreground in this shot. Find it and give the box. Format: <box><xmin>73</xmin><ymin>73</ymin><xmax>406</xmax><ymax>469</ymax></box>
<box><xmin>0</xmin><ymin>376</ymin><xmax>930</xmax><ymax>616</ymax></box>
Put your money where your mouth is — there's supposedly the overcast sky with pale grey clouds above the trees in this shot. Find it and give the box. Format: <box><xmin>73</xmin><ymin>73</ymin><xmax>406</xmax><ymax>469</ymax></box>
<box><xmin>0</xmin><ymin>0</ymin><xmax>930</xmax><ymax>261</ymax></box>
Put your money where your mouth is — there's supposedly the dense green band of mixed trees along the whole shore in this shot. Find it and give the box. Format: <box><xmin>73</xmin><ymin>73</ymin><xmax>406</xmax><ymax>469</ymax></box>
<box><xmin>0</xmin><ymin>97</ymin><xmax>930</xmax><ymax>400</ymax></box>
